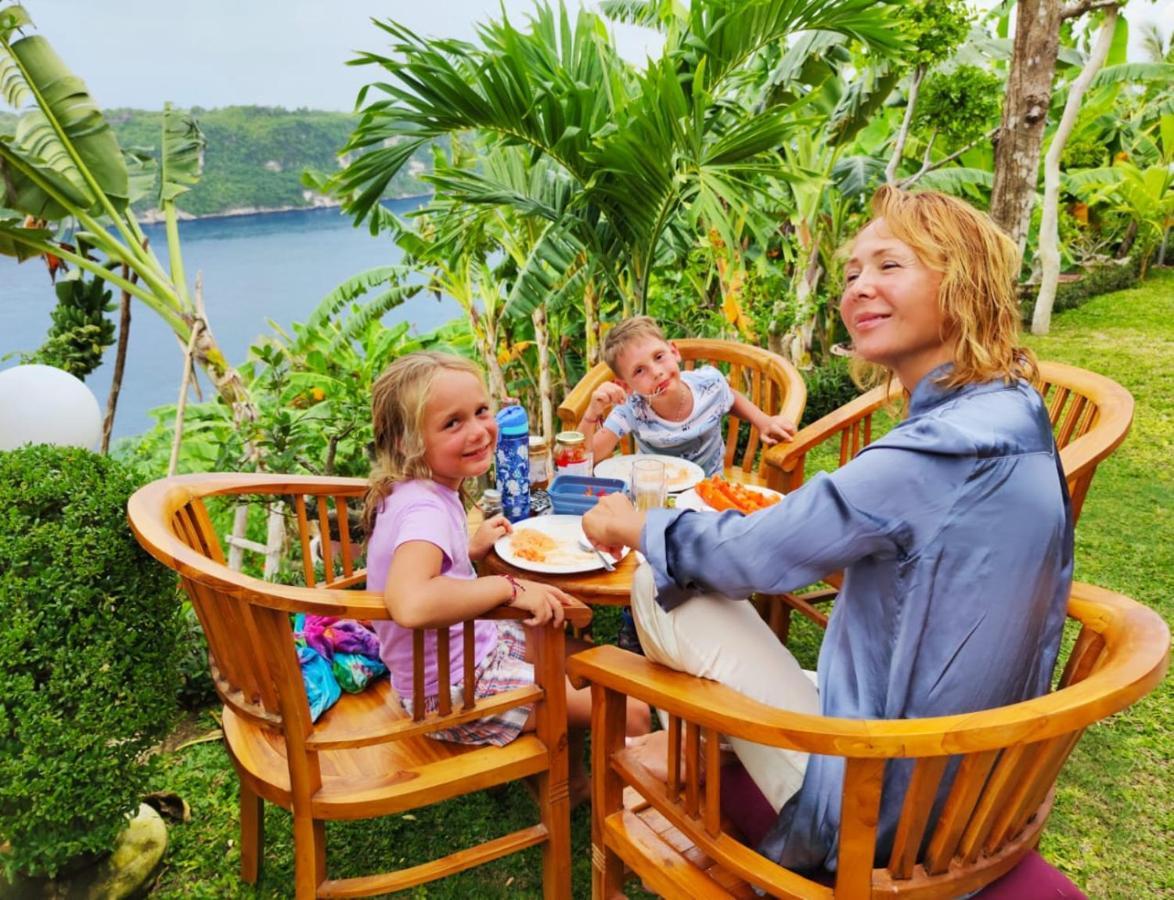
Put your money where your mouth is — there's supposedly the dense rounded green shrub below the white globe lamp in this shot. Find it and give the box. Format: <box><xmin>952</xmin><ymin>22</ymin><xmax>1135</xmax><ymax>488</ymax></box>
<box><xmin>0</xmin><ymin>446</ymin><xmax>180</xmax><ymax>877</ymax></box>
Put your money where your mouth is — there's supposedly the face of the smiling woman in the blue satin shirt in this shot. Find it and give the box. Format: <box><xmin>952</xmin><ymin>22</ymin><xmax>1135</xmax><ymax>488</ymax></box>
<box><xmin>839</xmin><ymin>218</ymin><xmax>953</xmax><ymax>390</ymax></box>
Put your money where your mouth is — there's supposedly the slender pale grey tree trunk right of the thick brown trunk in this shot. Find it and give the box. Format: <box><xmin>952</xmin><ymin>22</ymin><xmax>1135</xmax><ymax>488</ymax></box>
<box><xmin>1031</xmin><ymin>7</ymin><xmax>1116</xmax><ymax>334</ymax></box>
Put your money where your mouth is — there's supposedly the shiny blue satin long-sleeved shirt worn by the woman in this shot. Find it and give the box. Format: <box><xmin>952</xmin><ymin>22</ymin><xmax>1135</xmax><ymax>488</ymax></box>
<box><xmin>641</xmin><ymin>368</ymin><xmax>1073</xmax><ymax>869</ymax></box>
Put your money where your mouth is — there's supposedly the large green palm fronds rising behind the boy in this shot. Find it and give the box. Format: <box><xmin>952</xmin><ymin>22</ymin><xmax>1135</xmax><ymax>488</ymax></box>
<box><xmin>333</xmin><ymin>0</ymin><xmax>903</xmax><ymax>311</ymax></box>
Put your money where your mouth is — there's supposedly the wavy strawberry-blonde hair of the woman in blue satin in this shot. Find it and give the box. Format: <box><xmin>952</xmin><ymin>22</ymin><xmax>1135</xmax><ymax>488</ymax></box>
<box><xmin>872</xmin><ymin>185</ymin><xmax>1038</xmax><ymax>390</ymax></box>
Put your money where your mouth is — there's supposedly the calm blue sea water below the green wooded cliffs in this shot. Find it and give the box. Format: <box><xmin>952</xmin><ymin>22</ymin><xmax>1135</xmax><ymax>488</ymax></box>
<box><xmin>0</xmin><ymin>199</ymin><xmax>460</xmax><ymax>438</ymax></box>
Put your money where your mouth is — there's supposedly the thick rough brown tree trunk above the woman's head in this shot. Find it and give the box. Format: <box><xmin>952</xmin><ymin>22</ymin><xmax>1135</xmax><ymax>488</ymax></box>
<box><xmin>991</xmin><ymin>0</ymin><xmax>1062</xmax><ymax>252</ymax></box>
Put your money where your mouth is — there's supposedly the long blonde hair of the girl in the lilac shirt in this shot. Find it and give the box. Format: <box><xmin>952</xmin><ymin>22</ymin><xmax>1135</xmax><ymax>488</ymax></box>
<box><xmin>363</xmin><ymin>350</ymin><xmax>481</xmax><ymax>539</ymax></box>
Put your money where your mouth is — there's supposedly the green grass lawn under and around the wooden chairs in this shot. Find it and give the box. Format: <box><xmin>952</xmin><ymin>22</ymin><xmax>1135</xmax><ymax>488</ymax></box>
<box><xmin>142</xmin><ymin>270</ymin><xmax>1174</xmax><ymax>899</ymax></box>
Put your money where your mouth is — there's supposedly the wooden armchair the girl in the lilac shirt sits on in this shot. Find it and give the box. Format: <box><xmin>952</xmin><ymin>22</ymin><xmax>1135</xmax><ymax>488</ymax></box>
<box><xmin>128</xmin><ymin>474</ymin><xmax>591</xmax><ymax>898</ymax></box>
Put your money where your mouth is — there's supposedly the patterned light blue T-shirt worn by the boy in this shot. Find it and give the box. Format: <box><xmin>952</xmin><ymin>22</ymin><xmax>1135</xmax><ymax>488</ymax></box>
<box><xmin>603</xmin><ymin>366</ymin><xmax>734</xmax><ymax>475</ymax></box>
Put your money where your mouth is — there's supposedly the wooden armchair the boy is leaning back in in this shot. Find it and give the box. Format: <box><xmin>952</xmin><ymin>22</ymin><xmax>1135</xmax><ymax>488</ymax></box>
<box><xmin>559</xmin><ymin>338</ymin><xmax>807</xmax><ymax>485</ymax></box>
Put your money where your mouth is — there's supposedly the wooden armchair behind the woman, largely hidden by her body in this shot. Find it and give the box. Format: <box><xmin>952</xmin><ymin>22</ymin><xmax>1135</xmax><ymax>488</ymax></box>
<box><xmin>763</xmin><ymin>361</ymin><xmax>1133</xmax><ymax>641</ymax></box>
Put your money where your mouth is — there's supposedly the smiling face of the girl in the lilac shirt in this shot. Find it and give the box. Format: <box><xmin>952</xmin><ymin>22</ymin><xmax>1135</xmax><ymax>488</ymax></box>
<box><xmin>424</xmin><ymin>368</ymin><xmax>498</xmax><ymax>490</ymax></box>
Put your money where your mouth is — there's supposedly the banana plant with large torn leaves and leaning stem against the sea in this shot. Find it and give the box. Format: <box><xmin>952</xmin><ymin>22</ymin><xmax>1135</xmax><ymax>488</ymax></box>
<box><xmin>0</xmin><ymin>5</ymin><xmax>256</xmax><ymax>424</ymax></box>
